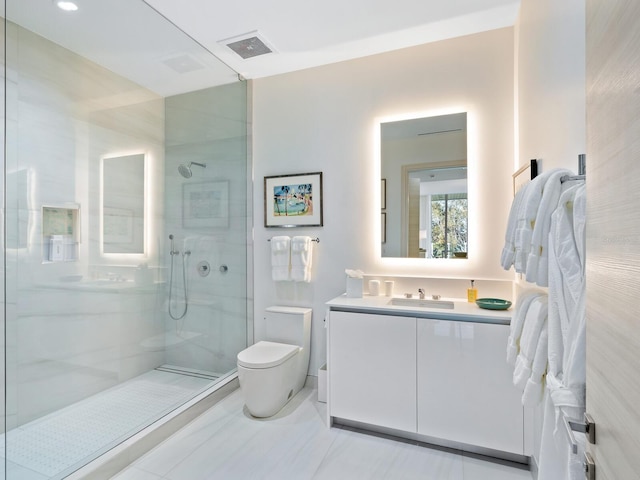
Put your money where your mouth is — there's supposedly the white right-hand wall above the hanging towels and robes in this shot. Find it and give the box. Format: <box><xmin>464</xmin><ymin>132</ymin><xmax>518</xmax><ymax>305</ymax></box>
<box><xmin>514</xmin><ymin>0</ymin><xmax>589</xmax><ymax>459</ymax></box>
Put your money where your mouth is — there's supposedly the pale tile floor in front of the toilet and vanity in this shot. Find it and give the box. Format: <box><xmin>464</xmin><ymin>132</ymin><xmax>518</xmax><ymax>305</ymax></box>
<box><xmin>114</xmin><ymin>387</ymin><xmax>532</xmax><ymax>480</ymax></box>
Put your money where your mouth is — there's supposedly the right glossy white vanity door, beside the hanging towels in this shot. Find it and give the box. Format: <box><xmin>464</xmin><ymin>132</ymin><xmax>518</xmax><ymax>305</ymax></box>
<box><xmin>417</xmin><ymin>318</ymin><xmax>524</xmax><ymax>455</ymax></box>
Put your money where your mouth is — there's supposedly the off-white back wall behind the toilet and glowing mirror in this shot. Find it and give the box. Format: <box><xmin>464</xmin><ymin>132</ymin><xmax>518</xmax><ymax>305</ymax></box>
<box><xmin>253</xmin><ymin>28</ymin><xmax>514</xmax><ymax>374</ymax></box>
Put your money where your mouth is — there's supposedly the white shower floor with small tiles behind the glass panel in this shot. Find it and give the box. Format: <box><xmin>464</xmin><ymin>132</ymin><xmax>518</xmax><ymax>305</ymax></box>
<box><xmin>0</xmin><ymin>365</ymin><xmax>228</xmax><ymax>480</ymax></box>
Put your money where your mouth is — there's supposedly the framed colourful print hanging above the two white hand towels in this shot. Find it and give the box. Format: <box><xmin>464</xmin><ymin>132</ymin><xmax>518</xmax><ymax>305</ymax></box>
<box><xmin>264</xmin><ymin>172</ymin><xmax>323</xmax><ymax>227</ymax></box>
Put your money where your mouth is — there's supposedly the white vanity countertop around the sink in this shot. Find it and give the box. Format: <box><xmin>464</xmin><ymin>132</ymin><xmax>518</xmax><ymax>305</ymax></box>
<box><xmin>326</xmin><ymin>294</ymin><xmax>514</xmax><ymax>325</ymax></box>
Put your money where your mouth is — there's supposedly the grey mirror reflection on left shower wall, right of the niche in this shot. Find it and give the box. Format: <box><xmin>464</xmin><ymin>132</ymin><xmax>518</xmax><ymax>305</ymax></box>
<box><xmin>101</xmin><ymin>154</ymin><xmax>145</xmax><ymax>254</ymax></box>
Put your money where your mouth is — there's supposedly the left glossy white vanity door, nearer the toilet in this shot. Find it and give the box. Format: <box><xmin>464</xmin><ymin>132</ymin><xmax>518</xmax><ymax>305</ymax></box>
<box><xmin>328</xmin><ymin>312</ymin><xmax>416</xmax><ymax>432</ymax></box>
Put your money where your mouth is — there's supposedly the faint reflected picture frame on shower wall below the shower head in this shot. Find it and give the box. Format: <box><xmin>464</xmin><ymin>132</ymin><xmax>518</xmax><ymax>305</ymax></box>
<box><xmin>182</xmin><ymin>180</ymin><xmax>229</xmax><ymax>228</ymax></box>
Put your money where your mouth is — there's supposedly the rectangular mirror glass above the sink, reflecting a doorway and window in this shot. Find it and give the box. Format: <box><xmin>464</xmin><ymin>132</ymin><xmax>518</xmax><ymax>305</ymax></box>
<box><xmin>380</xmin><ymin>113</ymin><xmax>469</xmax><ymax>261</ymax></box>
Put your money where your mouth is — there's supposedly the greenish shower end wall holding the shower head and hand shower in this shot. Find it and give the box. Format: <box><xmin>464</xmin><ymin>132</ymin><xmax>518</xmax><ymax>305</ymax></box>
<box><xmin>165</xmin><ymin>82</ymin><xmax>250</xmax><ymax>373</ymax></box>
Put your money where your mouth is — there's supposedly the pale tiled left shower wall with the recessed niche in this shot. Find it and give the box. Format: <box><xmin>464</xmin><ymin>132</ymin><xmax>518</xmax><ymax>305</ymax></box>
<box><xmin>6</xmin><ymin>24</ymin><xmax>164</xmax><ymax>428</ymax></box>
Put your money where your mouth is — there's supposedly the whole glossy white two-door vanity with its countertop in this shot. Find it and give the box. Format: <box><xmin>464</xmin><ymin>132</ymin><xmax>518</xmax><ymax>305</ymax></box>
<box><xmin>327</xmin><ymin>296</ymin><xmax>526</xmax><ymax>461</ymax></box>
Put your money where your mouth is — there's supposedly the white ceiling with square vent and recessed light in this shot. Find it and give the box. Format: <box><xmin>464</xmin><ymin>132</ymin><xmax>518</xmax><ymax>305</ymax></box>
<box><xmin>7</xmin><ymin>0</ymin><xmax>520</xmax><ymax>96</ymax></box>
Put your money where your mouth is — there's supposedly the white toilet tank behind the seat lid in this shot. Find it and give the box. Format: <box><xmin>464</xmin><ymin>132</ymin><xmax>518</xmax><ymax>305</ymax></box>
<box><xmin>264</xmin><ymin>306</ymin><xmax>312</xmax><ymax>348</ymax></box>
